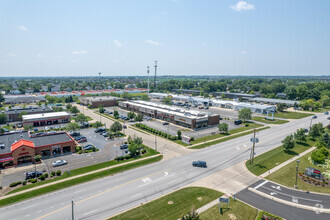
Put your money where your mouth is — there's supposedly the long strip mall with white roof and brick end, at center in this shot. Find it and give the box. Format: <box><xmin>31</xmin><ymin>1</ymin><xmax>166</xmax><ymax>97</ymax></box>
<box><xmin>118</xmin><ymin>101</ymin><xmax>220</xmax><ymax>129</ymax></box>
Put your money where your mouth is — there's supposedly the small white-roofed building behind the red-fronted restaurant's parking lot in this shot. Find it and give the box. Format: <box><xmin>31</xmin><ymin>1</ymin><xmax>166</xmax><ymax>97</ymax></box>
<box><xmin>22</xmin><ymin>112</ymin><xmax>70</xmax><ymax>127</ymax></box>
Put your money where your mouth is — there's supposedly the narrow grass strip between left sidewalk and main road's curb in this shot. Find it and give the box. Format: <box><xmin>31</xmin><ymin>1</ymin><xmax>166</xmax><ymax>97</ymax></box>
<box><xmin>0</xmin><ymin>155</ymin><xmax>163</xmax><ymax>207</ymax></box>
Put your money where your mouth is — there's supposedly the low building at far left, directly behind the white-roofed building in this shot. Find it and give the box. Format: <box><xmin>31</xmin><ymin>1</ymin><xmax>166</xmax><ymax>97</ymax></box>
<box><xmin>2</xmin><ymin>107</ymin><xmax>53</xmax><ymax>122</ymax></box>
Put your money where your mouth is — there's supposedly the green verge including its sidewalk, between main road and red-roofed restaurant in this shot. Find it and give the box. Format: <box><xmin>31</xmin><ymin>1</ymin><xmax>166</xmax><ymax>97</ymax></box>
<box><xmin>0</xmin><ymin>154</ymin><xmax>163</xmax><ymax>207</ymax></box>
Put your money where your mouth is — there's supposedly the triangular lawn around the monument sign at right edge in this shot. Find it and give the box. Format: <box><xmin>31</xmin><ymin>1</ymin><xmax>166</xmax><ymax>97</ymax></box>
<box><xmin>266</xmin><ymin>149</ymin><xmax>330</xmax><ymax>193</ymax></box>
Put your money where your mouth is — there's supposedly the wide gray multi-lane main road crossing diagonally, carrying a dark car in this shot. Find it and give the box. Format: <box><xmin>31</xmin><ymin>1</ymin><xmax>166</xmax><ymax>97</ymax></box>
<box><xmin>0</xmin><ymin>114</ymin><xmax>328</xmax><ymax>219</ymax></box>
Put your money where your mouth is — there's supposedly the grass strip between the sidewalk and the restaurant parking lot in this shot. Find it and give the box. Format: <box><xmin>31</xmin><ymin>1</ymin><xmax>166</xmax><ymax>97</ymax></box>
<box><xmin>7</xmin><ymin>145</ymin><xmax>159</xmax><ymax>194</ymax></box>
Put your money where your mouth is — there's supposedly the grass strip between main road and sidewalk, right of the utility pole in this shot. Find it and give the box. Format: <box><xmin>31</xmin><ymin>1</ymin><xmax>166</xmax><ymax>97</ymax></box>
<box><xmin>246</xmin><ymin>140</ymin><xmax>314</xmax><ymax>176</ymax></box>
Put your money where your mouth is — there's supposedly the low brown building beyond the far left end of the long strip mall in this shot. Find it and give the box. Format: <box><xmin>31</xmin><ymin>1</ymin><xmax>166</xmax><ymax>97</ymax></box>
<box><xmin>79</xmin><ymin>96</ymin><xmax>124</xmax><ymax>108</ymax></box>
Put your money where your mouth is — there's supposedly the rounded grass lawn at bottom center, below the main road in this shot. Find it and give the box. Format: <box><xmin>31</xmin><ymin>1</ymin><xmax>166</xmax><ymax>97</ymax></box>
<box><xmin>110</xmin><ymin>187</ymin><xmax>223</xmax><ymax>220</ymax></box>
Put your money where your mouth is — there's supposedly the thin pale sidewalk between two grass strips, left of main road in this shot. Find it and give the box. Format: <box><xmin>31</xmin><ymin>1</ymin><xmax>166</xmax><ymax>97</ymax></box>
<box><xmin>0</xmin><ymin>154</ymin><xmax>161</xmax><ymax>199</ymax></box>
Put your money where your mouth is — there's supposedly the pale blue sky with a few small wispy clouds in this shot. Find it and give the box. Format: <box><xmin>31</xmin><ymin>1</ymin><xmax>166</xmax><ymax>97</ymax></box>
<box><xmin>0</xmin><ymin>0</ymin><xmax>330</xmax><ymax>76</ymax></box>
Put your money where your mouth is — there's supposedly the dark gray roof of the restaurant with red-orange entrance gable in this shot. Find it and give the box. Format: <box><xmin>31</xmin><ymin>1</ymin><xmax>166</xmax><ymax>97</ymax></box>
<box><xmin>0</xmin><ymin>131</ymin><xmax>72</xmax><ymax>154</ymax></box>
